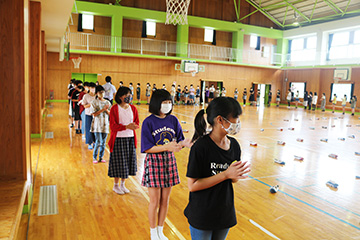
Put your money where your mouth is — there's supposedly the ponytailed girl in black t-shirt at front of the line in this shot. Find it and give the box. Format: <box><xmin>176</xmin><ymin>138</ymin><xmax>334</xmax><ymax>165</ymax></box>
<box><xmin>184</xmin><ymin>97</ymin><xmax>250</xmax><ymax>240</ymax></box>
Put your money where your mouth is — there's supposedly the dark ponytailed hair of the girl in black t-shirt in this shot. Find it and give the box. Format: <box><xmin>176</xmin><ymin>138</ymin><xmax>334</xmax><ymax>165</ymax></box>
<box><xmin>191</xmin><ymin>97</ymin><xmax>242</xmax><ymax>142</ymax></box>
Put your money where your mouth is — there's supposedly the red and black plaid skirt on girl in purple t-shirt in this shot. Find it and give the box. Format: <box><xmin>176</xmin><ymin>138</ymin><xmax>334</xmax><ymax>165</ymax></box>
<box><xmin>141</xmin><ymin>152</ymin><xmax>180</xmax><ymax>188</ymax></box>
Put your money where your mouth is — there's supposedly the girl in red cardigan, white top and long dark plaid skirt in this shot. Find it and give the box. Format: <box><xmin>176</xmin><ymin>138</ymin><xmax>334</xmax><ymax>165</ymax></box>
<box><xmin>108</xmin><ymin>87</ymin><xmax>139</xmax><ymax>194</ymax></box>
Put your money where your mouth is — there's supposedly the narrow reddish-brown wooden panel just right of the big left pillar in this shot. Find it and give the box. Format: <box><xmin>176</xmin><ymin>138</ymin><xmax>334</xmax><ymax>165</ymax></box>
<box><xmin>30</xmin><ymin>1</ymin><xmax>41</xmax><ymax>134</ymax></box>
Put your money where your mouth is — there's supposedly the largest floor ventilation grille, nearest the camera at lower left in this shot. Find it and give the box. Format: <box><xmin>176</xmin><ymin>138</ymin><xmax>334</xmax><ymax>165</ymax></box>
<box><xmin>38</xmin><ymin>185</ymin><xmax>59</xmax><ymax>216</ymax></box>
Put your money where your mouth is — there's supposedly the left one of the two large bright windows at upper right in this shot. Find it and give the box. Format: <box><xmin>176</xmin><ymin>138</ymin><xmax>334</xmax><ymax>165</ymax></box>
<box><xmin>290</xmin><ymin>36</ymin><xmax>317</xmax><ymax>62</ymax></box>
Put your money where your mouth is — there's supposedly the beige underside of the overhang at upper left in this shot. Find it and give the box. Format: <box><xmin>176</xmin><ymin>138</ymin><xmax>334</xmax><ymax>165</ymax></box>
<box><xmin>40</xmin><ymin>0</ymin><xmax>75</xmax><ymax>52</ymax></box>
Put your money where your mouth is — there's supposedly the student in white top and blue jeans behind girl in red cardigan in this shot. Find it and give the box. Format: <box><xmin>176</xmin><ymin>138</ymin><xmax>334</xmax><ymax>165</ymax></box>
<box><xmin>90</xmin><ymin>85</ymin><xmax>111</xmax><ymax>164</ymax></box>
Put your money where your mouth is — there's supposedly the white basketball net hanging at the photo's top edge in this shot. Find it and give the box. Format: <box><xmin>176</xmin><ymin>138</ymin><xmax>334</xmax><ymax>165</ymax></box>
<box><xmin>165</xmin><ymin>0</ymin><xmax>190</xmax><ymax>25</ymax></box>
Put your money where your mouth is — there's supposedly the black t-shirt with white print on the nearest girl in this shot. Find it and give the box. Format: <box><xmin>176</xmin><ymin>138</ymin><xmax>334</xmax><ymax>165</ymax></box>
<box><xmin>184</xmin><ymin>135</ymin><xmax>241</xmax><ymax>230</ymax></box>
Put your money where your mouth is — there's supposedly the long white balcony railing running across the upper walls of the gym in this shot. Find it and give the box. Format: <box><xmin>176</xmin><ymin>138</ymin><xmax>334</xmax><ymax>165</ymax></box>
<box><xmin>64</xmin><ymin>31</ymin><xmax>360</xmax><ymax>66</ymax></box>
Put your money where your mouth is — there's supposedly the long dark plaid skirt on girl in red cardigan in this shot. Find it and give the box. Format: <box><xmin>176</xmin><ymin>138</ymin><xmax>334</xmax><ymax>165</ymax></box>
<box><xmin>108</xmin><ymin>137</ymin><xmax>137</xmax><ymax>178</ymax></box>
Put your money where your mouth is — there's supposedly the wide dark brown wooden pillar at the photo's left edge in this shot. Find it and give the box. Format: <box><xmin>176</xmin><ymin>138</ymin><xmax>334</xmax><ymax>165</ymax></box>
<box><xmin>0</xmin><ymin>0</ymin><xmax>31</xmax><ymax>179</ymax></box>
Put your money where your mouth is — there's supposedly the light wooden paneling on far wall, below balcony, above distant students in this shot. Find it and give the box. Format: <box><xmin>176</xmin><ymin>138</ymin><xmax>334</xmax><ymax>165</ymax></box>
<box><xmin>46</xmin><ymin>53</ymin><xmax>282</xmax><ymax>99</ymax></box>
